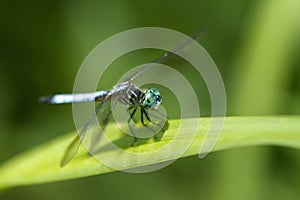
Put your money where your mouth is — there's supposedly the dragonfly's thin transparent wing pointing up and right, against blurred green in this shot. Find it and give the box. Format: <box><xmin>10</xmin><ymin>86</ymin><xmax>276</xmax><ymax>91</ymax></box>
<box><xmin>127</xmin><ymin>30</ymin><xmax>206</xmax><ymax>81</ymax></box>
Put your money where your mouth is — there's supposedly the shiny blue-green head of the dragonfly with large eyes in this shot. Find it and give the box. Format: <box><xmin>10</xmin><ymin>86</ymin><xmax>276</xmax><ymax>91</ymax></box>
<box><xmin>143</xmin><ymin>88</ymin><xmax>162</xmax><ymax>109</ymax></box>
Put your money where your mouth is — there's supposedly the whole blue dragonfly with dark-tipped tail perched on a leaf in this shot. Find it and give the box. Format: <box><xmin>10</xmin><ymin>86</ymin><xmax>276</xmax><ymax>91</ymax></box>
<box><xmin>39</xmin><ymin>31</ymin><xmax>203</xmax><ymax>167</ymax></box>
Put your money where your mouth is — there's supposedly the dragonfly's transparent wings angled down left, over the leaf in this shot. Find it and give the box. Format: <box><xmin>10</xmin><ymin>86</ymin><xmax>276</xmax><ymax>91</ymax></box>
<box><xmin>61</xmin><ymin>95</ymin><xmax>111</xmax><ymax>167</ymax></box>
